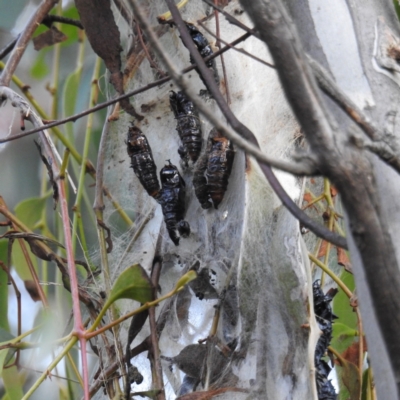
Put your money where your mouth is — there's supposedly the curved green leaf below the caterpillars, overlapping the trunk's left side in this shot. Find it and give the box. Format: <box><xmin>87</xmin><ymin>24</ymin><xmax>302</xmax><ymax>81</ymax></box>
<box><xmin>105</xmin><ymin>264</ymin><xmax>153</xmax><ymax>307</ymax></box>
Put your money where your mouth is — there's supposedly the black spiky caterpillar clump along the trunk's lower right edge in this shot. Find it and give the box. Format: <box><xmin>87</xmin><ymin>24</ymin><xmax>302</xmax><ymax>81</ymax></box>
<box><xmin>313</xmin><ymin>280</ymin><xmax>337</xmax><ymax>400</ymax></box>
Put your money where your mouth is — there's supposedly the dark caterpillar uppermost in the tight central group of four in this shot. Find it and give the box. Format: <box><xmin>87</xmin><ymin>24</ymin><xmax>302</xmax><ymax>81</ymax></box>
<box><xmin>169</xmin><ymin>91</ymin><xmax>203</xmax><ymax>165</ymax></box>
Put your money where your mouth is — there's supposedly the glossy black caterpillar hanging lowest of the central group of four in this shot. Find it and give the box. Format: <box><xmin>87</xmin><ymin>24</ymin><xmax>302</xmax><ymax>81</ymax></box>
<box><xmin>157</xmin><ymin>161</ymin><xmax>190</xmax><ymax>246</ymax></box>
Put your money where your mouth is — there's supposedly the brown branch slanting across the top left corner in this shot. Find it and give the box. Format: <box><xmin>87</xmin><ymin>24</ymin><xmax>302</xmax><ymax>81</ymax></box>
<box><xmin>0</xmin><ymin>0</ymin><xmax>57</xmax><ymax>86</ymax></box>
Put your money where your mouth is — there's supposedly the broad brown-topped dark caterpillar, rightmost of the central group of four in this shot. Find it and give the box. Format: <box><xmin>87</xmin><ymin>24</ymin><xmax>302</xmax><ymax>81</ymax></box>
<box><xmin>193</xmin><ymin>128</ymin><xmax>235</xmax><ymax>209</ymax></box>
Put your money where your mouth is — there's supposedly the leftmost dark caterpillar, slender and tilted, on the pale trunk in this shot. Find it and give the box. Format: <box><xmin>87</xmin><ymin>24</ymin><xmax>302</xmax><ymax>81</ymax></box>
<box><xmin>126</xmin><ymin>126</ymin><xmax>160</xmax><ymax>198</ymax></box>
